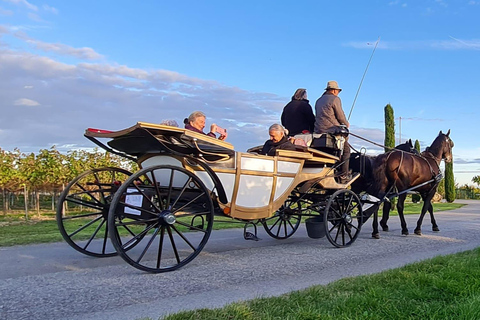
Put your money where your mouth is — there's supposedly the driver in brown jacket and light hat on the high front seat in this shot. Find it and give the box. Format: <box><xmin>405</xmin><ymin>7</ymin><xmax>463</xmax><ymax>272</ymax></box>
<box><xmin>314</xmin><ymin>81</ymin><xmax>350</xmax><ymax>182</ymax></box>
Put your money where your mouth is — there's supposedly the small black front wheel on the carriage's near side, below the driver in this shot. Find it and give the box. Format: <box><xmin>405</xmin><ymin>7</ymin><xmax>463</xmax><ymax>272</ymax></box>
<box><xmin>323</xmin><ymin>189</ymin><xmax>362</xmax><ymax>248</ymax></box>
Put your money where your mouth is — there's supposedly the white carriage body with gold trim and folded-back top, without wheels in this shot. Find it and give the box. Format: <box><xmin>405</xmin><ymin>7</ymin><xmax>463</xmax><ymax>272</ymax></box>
<box><xmin>85</xmin><ymin>122</ymin><xmax>345</xmax><ymax>220</ymax></box>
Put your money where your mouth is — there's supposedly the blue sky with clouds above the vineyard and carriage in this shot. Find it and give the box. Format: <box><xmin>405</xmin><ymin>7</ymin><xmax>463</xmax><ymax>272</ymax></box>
<box><xmin>0</xmin><ymin>0</ymin><xmax>480</xmax><ymax>185</ymax></box>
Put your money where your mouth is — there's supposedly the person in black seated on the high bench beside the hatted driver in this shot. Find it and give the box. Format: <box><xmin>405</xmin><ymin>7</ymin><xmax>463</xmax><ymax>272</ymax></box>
<box><xmin>281</xmin><ymin>88</ymin><xmax>315</xmax><ymax>136</ymax></box>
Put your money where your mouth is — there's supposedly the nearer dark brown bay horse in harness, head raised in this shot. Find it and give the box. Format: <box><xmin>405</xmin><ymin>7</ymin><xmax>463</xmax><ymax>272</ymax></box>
<box><xmin>372</xmin><ymin>130</ymin><xmax>454</xmax><ymax>235</ymax></box>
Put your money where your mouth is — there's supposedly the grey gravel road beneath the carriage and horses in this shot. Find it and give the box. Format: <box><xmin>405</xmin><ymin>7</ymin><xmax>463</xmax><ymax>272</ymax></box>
<box><xmin>0</xmin><ymin>200</ymin><xmax>480</xmax><ymax>320</ymax></box>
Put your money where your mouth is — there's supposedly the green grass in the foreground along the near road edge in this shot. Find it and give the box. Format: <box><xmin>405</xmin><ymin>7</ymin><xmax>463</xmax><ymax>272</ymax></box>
<box><xmin>161</xmin><ymin>249</ymin><xmax>480</xmax><ymax>320</ymax></box>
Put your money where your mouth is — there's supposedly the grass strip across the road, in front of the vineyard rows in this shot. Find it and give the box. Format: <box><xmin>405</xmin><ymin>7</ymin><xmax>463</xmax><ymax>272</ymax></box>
<box><xmin>0</xmin><ymin>203</ymin><xmax>462</xmax><ymax>247</ymax></box>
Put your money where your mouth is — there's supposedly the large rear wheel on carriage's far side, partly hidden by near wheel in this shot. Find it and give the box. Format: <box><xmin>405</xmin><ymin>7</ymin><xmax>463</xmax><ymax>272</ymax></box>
<box><xmin>56</xmin><ymin>168</ymin><xmax>131</xmax><ymax>257</ymax></box>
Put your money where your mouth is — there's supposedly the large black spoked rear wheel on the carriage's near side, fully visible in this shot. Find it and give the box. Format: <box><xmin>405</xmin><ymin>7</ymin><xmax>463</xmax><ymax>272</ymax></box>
<box><xmin>108</xmin><ymin>165</ymin><xmax>214</xmax><ymax>273</ymax></box>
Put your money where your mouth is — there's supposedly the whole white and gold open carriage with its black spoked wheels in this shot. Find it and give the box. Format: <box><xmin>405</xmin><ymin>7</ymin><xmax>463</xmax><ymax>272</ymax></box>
<box><xmin>57</xmin><ymin>122</ymin><xmax>454</xmax><ymax>272</ymax></box>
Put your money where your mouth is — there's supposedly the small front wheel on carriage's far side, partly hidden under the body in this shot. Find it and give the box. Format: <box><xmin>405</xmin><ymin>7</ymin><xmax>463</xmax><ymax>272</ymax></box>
<box><xmin>260</xmin><ymin>192</ymin><xmax>307</xmax><ymax>239</ymax></box>
